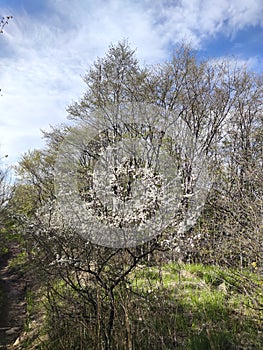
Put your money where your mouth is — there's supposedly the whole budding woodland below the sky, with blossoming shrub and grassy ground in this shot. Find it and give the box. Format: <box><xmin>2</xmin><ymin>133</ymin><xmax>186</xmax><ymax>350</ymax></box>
<box><xmin>0</xmin><ymin>40</ymin><xmax>263</xmax><ymax>350</ymax></box>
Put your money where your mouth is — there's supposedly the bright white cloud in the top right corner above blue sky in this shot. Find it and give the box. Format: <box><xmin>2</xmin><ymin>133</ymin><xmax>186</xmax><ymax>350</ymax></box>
<box><xmin>151</xmin><ymin>0</ymin><xmax>263</xmax><ymax>48</ymax></box>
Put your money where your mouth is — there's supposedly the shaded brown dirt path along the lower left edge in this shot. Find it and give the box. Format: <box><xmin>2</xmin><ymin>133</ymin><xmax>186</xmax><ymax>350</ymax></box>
<box><xmin>0</xmin><ymin>246</ymin><xmax>26</xmax><ymax>349</ymax></box>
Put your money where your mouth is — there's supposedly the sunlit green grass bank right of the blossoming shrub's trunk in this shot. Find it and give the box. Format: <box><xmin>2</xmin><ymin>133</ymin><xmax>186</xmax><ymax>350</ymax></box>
<box><xmin>132</xmin><ymin>263</ymin><xmax>263</xmax><ymax>350</ymax></box>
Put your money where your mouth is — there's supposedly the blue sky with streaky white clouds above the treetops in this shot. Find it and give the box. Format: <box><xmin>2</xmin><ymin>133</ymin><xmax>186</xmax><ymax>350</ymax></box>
<box><xmin>0</xmin><ymin>0</ymin><xmax>263</xmax><ymax>167</ymax></box>
